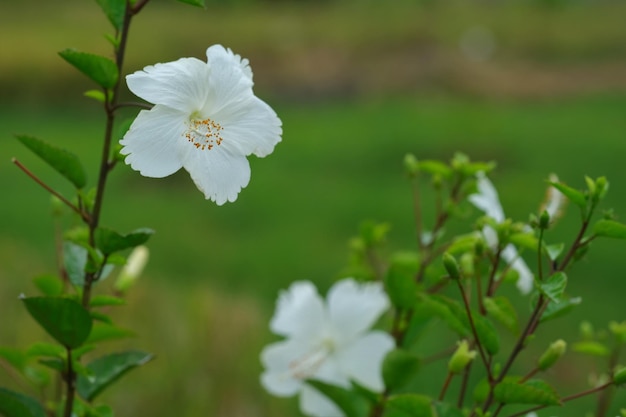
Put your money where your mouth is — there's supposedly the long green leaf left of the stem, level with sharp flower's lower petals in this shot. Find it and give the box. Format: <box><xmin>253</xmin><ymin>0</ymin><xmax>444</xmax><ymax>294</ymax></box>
<box><xmin>16</xmin><ymin>135</ymin><xmax>87</xmax><ymax>188</ymax></box>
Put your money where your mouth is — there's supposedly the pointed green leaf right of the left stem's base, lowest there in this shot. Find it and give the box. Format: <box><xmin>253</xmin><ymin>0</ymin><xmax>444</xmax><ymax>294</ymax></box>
<box><xmin>76</xmin><ymin>351</ymin><xmax>153</xmax><ymax>401</ymax></box>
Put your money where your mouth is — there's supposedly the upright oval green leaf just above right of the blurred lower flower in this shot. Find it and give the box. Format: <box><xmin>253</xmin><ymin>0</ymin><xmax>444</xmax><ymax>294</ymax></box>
<box><xmin>385</xmin><ymin>253</ymin><xmax>419</xmax><ymax>308</ymax></box>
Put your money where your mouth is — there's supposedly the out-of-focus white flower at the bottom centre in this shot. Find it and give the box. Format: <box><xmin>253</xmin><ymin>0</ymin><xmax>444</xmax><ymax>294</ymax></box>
<box><xmin>261</xmin><ymin>278</ymin><xmax>394</xmax><ymax>417</ymax></box>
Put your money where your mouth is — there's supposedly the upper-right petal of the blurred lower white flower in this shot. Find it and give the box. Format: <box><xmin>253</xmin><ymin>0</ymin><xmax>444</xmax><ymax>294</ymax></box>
<box><xmin>327</xmin><ymin>278</ymin><xmax>389</xmax><ymax>343</ymax></box>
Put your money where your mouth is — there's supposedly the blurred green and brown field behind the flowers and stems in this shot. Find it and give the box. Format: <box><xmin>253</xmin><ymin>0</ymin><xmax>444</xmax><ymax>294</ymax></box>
<box><xmin>0</xmin><ymin>0</ymin><xmax>626</xmax><ymax>417</ymax></box>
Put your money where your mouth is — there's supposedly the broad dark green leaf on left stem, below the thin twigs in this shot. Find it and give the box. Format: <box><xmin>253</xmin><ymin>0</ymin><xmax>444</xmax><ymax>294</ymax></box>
<box><xmin>22</xmin><ymin>297</ymin><xmax>92</xmax><ymax>349</ymax></box>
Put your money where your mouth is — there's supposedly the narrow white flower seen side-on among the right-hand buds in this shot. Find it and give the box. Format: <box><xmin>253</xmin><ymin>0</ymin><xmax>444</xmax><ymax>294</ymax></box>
<box><xmin>468</xmin><ymin>172</ymin><xmax>534</xmax><ymax>294</ymax></box>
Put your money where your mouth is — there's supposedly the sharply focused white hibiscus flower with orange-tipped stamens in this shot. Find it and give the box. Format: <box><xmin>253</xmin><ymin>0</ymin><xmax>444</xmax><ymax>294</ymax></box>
<box><xmin>120</xmin><ymin>45</ymin><xmax>282</xmax><ymax>205</ymax></box>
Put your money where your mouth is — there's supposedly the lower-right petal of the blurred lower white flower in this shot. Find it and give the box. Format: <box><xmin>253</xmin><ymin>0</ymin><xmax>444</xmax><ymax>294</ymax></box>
<box><xmin>337</xmin><ymin>331</ymin><xmax>395</xmax><ymax>392</ymax></box>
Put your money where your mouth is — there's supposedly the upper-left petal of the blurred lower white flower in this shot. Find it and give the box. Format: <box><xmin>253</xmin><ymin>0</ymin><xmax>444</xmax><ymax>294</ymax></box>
<box><xmin>270</xmin><ymin>281</ymin><xmax>326</xmax><ymax>340</ymax></box>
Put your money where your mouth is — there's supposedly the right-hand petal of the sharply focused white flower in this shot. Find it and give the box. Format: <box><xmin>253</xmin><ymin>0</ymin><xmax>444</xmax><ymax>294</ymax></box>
<box><xmin>213</xmin><ymin>96</ymin><xmax>282</xmax><ymax>157</ymax></box>
